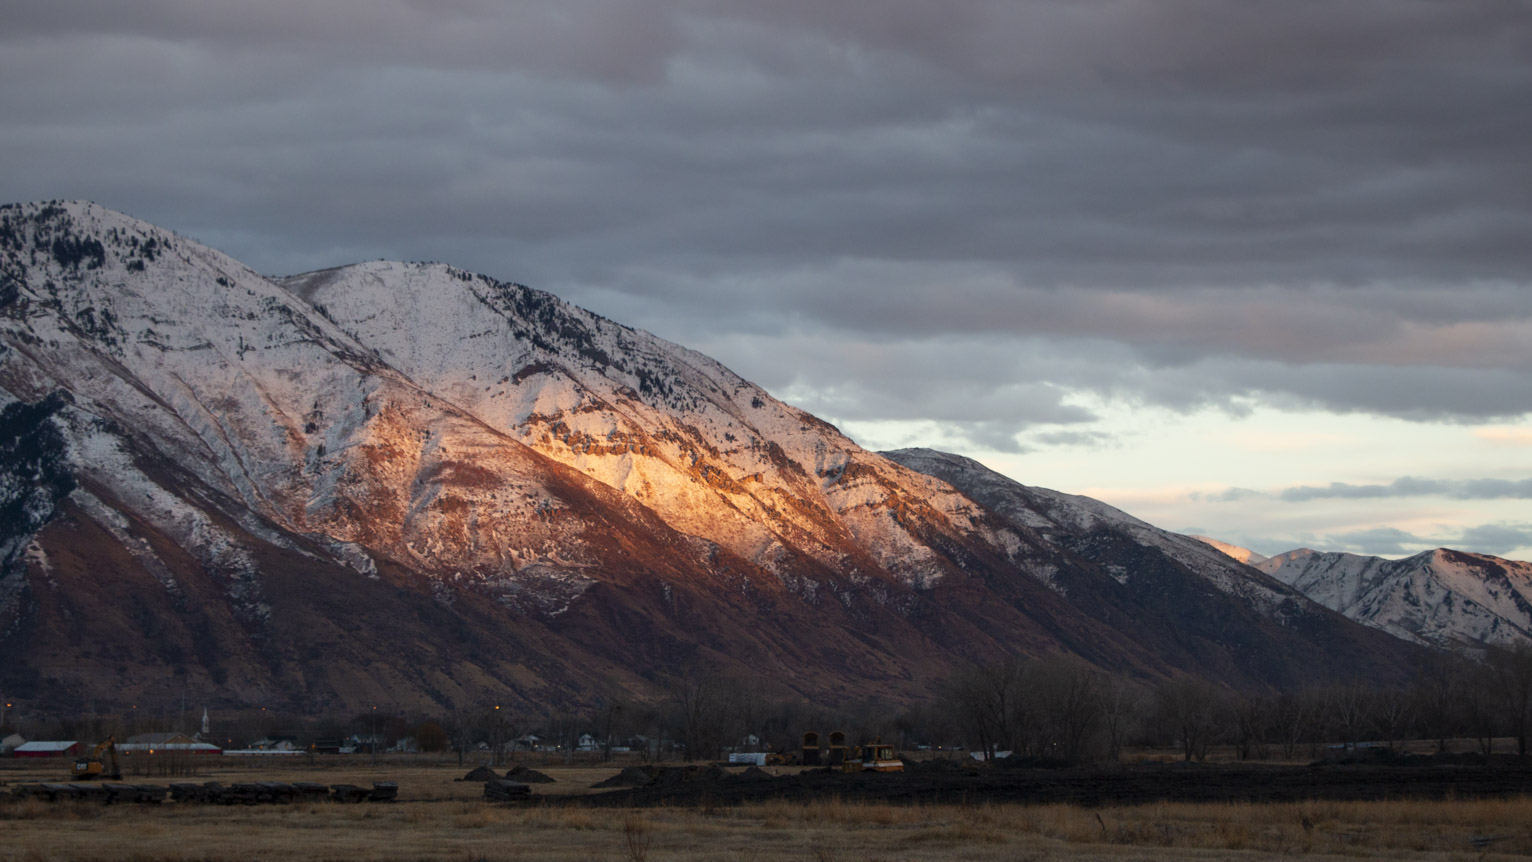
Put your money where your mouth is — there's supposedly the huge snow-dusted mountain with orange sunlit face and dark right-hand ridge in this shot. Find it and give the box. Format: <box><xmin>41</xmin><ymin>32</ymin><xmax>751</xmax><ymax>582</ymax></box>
<box><xmin>0</xmin><ymin>202</ymin><xmax>1411</xmax><ymax>712</ymax></box>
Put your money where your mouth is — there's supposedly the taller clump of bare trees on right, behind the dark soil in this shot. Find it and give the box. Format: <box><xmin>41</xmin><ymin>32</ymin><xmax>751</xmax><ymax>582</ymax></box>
<box><xmin>945</xmin><ymin>643</ymin><xmax>1532</xmax><ymax>762</ymax></box>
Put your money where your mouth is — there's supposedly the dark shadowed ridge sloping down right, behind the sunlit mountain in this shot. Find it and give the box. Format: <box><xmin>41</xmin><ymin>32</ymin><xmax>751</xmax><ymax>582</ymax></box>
<box><xmin>884</xmin><ymin>449</ymin><xmax>1421</xmax><ymax>684</ymax></box>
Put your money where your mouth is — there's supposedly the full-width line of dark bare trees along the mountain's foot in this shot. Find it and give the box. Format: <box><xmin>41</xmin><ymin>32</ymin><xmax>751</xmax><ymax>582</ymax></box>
<box><xmin>5</xmin><ymin>643</ymin><xmax>1532</xmax><ymax>762</ymax></box>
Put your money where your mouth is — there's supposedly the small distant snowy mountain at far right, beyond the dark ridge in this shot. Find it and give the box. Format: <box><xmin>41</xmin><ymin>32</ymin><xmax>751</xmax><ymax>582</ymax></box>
<box><xmin>1256</xmin><ymin>548</ymin><xmax>1532</xmax><ymax>646</ymax></box>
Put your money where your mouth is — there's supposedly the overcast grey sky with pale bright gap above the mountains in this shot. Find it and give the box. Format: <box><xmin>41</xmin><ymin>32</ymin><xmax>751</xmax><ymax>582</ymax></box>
<box><xmin>0</xmin><ymin>0</ymin><xmax>1532</xmax><ymax>559</ymax></box>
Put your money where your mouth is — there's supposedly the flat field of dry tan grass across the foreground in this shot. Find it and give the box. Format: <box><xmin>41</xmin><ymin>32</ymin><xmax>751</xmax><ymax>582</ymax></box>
<box><xmin>0</xmin><ymin>762</ymin><xmax>1532</xmax><ymax>862</ymax></box>
